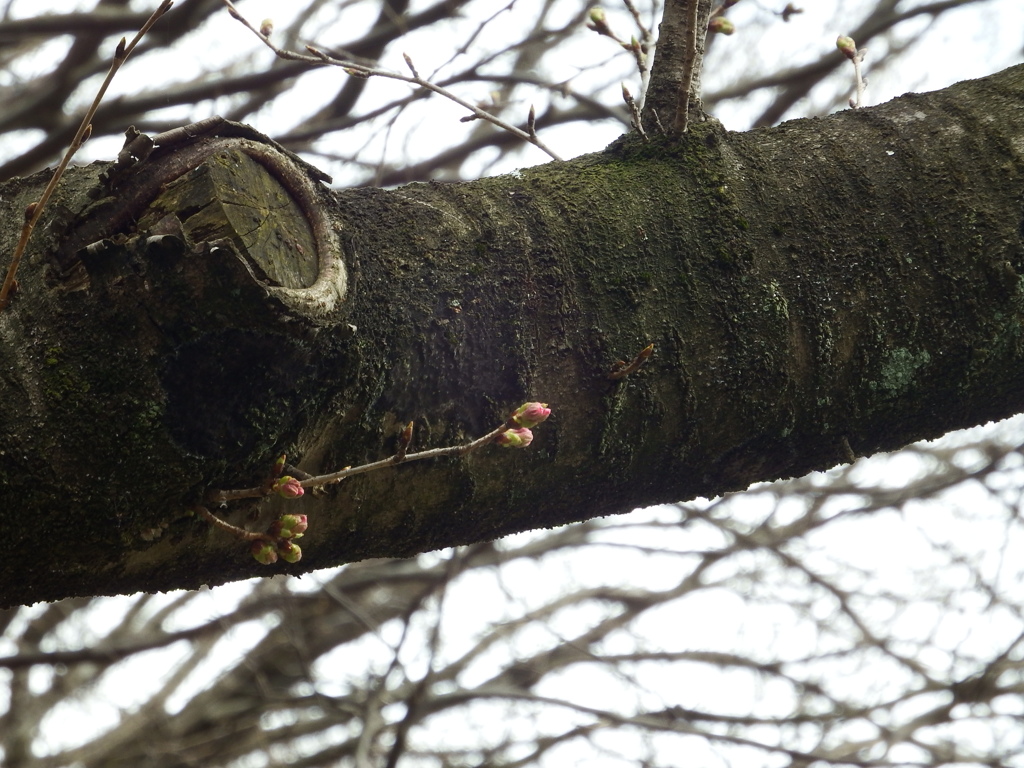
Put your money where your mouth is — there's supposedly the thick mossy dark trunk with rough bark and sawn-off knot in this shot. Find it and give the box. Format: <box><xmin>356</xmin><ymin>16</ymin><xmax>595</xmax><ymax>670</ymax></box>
<box><xmin>0</xmin><ymin>67</ymin><xmax>1024</xmax><ymax>605</ymax></box>
